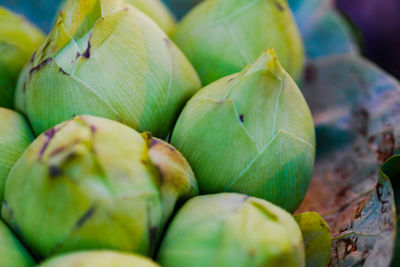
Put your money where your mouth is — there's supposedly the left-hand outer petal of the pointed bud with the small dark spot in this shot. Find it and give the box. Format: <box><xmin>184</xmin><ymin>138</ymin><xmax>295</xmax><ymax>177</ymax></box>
<box><xmin>171</xmin><ymin>98</ymin><xmax>257</xmax><ymax>193</ymax></box>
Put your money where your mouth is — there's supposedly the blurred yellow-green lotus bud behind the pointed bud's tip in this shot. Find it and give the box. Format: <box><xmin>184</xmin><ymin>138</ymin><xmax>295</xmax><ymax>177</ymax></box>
<box><xmin>173</xmin><ymin>0</ymin><xmax>304</xmax><ymax>84</ymax></box>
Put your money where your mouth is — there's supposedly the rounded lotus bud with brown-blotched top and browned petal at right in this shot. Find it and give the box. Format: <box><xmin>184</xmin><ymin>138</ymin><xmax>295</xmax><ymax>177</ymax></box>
<box><xmin>2</xmin><ymin>116</ymin><xmax>197</xmax><ymax>257</ymax></box>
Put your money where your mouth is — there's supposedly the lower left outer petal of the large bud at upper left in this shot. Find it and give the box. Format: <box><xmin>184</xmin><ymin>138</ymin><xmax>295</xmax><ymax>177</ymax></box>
<box><xmin>24</xmin><ymin>59</ymin><xmax>121</xmax><ymax>134</ymax></box>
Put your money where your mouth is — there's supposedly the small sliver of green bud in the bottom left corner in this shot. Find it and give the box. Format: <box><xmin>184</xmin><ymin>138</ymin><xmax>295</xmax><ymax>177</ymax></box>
<box><xmin>0</xmin><ymin>220</ymin><xmax>35</xmax><ymax>267</ymax></box>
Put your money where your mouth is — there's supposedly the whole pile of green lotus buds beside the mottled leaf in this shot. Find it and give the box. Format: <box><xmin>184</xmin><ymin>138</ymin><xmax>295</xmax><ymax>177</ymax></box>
<box><xmin>0</xmin><ymin>0</ymin><xmax>330</xmax><ymax>267</ymax></box>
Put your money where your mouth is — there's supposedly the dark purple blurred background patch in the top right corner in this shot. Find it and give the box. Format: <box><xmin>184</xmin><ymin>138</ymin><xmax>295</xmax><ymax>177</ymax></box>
<box><xmin>336</xmin><ymin>0</ymin><xmax>400</xmax><ymax>78</ymax></box>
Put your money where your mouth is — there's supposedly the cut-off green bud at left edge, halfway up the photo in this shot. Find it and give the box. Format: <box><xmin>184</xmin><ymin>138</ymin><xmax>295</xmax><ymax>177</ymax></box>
<box><xmin>0</xmin><ymin>108</ymin><xmax>33</xmax><ymax>207</ymax></box>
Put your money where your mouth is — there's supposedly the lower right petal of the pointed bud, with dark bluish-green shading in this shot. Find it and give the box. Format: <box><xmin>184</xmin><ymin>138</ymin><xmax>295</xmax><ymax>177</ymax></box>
<box><xmin>224</xmin><ymin>130</ymin><xmax>315</xmax><ymax>212</ymax></box>
